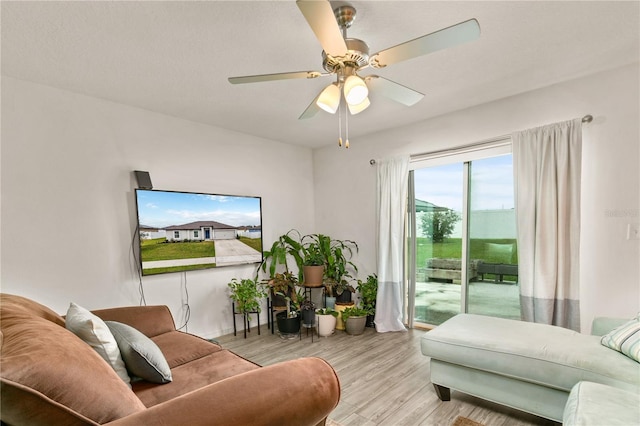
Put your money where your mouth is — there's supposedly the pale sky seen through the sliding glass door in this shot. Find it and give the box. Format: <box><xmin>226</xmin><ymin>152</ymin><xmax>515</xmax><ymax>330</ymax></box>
<box><xmin>414</xmin><ymin>155</ymin><xmax>514</xmax><ymax>212</ymax></box>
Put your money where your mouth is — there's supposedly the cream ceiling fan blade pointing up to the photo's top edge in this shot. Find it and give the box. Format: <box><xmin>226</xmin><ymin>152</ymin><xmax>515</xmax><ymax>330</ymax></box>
<box><xmin>296</xmin><ymin>0</ymin><xmax>348</xmax><ymax>56</ymax></box>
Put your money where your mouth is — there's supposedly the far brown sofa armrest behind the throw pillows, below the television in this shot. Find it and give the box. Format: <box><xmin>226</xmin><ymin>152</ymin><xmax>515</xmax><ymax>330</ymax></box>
<box><xmin>92</xmin><ymin>306</ymin><xmax>176</xmax><ymax>337</ymax></box>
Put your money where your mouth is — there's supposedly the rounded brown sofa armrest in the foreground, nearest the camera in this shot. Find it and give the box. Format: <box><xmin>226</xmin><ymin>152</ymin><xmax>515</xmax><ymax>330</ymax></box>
<box><xmin>107</xmin><ymin>358</ymin><xmax>340</xmax><ymax>426</ymax></box>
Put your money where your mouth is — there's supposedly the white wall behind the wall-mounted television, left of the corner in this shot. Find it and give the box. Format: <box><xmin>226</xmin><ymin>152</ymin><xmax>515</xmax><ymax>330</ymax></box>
<box><xmin>1</xmin><ymin>77</ymin><xmax>314</xmax><ymax>337</ymax></box>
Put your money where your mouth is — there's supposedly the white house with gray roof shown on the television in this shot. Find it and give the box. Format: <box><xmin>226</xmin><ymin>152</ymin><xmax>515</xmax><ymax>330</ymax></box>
<box><xmin>164</xmin><ymin>220</ymin><xmax>261</xmax><ymax>242</ymax></box>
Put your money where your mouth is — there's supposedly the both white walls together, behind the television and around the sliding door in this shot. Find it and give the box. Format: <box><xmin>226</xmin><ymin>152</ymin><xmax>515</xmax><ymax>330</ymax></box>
<box><xmin>0</xmin><ymin>65</ymin><xmax>640</xmax><ymax>337</ymax></box>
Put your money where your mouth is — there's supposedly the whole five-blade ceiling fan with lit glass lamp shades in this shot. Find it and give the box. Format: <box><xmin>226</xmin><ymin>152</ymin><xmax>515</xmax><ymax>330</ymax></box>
<box><xmin>229</xmin><ymin>0</ymin><xmax>480</xmax><ymax>141</ymax></box>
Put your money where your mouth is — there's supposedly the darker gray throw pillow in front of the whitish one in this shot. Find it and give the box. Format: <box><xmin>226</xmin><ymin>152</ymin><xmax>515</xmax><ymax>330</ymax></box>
<box><xmin>105</xmin><ymin>321</ymin><xmax>172</xmax><ymax>383</ymax></box>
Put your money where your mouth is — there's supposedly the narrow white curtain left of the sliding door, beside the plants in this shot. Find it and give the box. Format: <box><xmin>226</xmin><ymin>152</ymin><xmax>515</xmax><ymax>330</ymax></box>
<box><xmin>375</xmin><ymin>157</ymin><xmax>409</xmax><ymax>333</ymax></box>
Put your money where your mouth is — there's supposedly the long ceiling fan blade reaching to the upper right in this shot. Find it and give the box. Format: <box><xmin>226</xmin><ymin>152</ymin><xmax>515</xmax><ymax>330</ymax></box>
<box><xmin>369</xmin><ymin>19</ymin><xmax>480</xmax><ymax>68</ymax></box>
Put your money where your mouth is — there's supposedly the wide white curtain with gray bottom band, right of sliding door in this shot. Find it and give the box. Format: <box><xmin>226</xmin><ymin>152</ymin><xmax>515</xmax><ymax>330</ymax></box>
<box><xmin>512</xmin><ymin>119</ymin><xmax>582</xmax><ymax>331</ymax></box>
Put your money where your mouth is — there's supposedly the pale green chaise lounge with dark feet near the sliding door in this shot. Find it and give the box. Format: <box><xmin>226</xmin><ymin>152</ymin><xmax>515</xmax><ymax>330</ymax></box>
<box><xmin>421</xmin><ymin>314</ymin><xmax>640</xmax><ymax>422</ymax></box>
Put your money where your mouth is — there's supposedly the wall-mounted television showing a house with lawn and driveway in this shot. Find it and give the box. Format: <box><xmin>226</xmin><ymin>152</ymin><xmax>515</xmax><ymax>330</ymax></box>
<box><xmin>136</xmin><ymin>189</ymin><xmax>262</xmax><ymax>275</ymax></box>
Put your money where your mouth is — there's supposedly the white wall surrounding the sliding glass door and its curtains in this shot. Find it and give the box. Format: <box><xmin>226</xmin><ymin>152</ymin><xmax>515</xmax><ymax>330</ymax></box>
<box><xmin>314</xmin><ymin>64</ymin><xmax>640</xmax><ymax>332</ymax></box>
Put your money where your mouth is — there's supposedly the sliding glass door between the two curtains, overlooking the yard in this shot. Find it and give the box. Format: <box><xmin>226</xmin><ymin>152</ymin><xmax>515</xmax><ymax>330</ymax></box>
<box><xmin>407</xmin><ymin>153</ymin><xmax>520</xmax><ymax>325</ymax></box>
